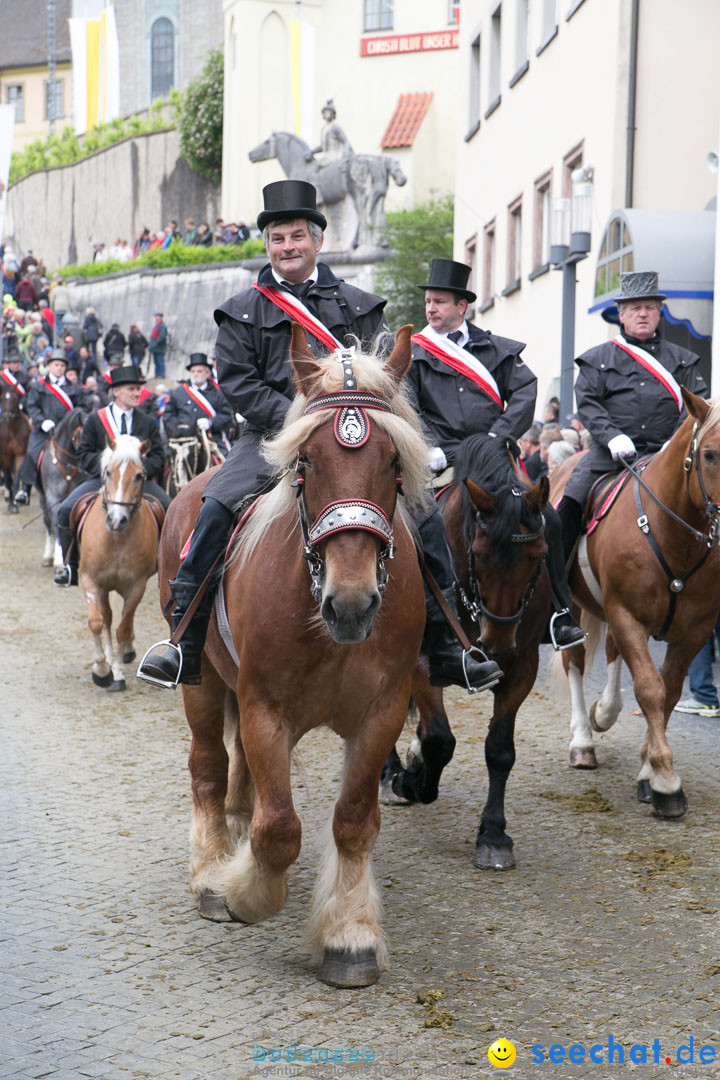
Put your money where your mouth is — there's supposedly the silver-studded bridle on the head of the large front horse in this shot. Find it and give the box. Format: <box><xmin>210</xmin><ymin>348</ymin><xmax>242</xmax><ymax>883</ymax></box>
<box><xmin>290</xmin><ymin>349</ymin><xmax>403</xmax><ymax>603</ymax></box>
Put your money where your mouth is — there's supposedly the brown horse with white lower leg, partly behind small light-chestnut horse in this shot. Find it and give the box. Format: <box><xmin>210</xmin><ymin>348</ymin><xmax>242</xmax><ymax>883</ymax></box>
<box><xmin>38</xmin><ymin>408</ymin><xmax>87</xmax><ymax>570</ymax></box>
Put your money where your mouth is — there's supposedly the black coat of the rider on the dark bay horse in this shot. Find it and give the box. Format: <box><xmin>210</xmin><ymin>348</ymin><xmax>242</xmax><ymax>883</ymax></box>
<box><xmin>406</xmin><ymin>323</ymin><xmax>538</xmax><ymax>463</ymax></box>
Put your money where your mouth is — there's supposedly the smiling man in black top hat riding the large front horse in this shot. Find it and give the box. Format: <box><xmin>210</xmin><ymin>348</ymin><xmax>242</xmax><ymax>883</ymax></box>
<box><xmin>138</xmin><ymin>180</ymin><xmax>499</xmax><ymax>688</ymax></box>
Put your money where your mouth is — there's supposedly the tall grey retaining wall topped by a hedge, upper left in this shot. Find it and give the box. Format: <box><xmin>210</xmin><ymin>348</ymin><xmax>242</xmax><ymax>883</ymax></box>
<box><xmin>4</xmin><ymin>129</ymin><xmax>220</xmax><ymax>270</ymax></box>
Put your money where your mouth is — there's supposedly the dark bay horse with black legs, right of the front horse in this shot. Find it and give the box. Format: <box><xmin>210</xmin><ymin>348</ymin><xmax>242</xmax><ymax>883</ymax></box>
<box><xmin>381</xmin><ymin>435</ymin><xmax>551</xmax><ymax>870</ymax></box>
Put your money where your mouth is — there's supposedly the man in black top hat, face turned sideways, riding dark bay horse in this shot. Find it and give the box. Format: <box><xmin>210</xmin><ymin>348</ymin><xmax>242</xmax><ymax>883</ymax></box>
<box><xmin>407</xmin><ymin>259</ymin><xmax>585</xmax><ymax>649</ymax></box>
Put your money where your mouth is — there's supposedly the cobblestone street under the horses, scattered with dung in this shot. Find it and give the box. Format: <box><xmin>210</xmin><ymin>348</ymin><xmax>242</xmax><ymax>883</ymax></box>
<box><xmin>0</xmin><ymin>500</ymin><xmax>720</xmax><ymax>1080</ymax></box>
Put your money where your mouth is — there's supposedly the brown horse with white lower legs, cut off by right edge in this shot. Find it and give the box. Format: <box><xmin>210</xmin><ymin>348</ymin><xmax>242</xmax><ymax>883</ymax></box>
<box><xmin>552</xmin><ymin>387</ymin><xmax>720</xmax><ymax>818</ymax></box>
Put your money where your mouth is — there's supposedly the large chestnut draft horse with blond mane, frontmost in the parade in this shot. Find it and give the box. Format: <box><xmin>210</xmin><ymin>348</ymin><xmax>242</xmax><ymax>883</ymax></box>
<box><xmin>159</xmin><ymin>324</ymin><xmax>427</xmax><ymax>986</ymax></box>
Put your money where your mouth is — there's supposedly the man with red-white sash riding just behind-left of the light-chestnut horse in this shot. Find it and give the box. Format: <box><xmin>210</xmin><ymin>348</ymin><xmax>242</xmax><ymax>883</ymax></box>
<box><xmin>15</xmin><ymin>349</ymin><xmax>85</xmax><ymax>504</ymax></box>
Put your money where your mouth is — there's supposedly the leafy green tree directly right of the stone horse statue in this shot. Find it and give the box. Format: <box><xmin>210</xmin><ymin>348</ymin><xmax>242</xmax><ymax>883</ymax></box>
<box><xmin>378</xmin><ymin>195</ymin><xmax>453</xmax><ymax>330</ymax></box>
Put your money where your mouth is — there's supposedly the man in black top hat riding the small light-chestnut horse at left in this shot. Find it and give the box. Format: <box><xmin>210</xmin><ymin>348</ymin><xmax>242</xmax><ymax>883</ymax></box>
<box><xmin>54</xmin><ymin>365</ymin><xmax>171</xmax><ymax>588</ymax></box>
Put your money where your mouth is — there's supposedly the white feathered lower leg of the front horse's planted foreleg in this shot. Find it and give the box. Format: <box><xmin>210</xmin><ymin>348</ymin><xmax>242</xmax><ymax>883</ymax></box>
<box><xmin>309</xmin><ymin>812</ymin><xmax>388</xmax><ymax>968</ymax></box>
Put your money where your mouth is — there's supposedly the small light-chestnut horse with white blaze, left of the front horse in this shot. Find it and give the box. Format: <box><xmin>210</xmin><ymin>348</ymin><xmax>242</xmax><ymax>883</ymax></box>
<box><xmin>79</xmin><ymin>435</ymin><xmax>159</xmax><ymax>690</ymax></box>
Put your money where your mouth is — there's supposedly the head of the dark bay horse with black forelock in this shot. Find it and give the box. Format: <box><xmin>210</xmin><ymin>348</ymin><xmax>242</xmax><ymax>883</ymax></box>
<box><xmin>456</xmin><ymin>438</ymin><xmax>549</xmax><ymax>658</ymax></box>
